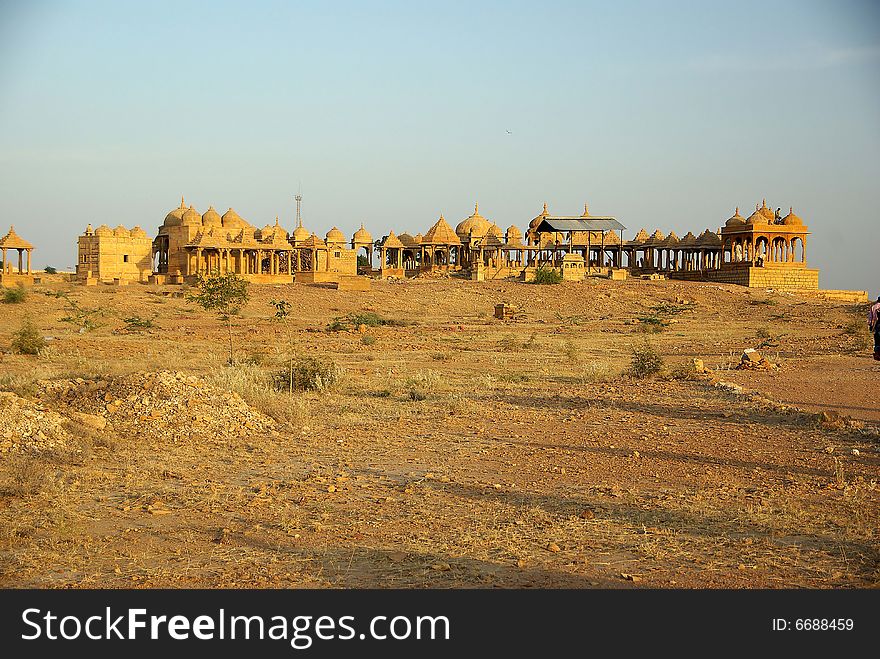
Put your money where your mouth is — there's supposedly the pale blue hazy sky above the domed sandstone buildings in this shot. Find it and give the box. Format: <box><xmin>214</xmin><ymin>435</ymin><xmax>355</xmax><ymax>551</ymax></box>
<box><xmin>0</xmin><ymin>0</ymin><xmax>880</xmax><ymax>296</ymax></box>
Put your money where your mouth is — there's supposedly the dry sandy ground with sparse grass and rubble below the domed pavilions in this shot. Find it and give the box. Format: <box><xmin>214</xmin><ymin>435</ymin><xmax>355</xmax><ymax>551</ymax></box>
<box><xmin>0</xmin><ymin>279</ymin><xmax>880</xmax><ymax>588</ymax></box>
